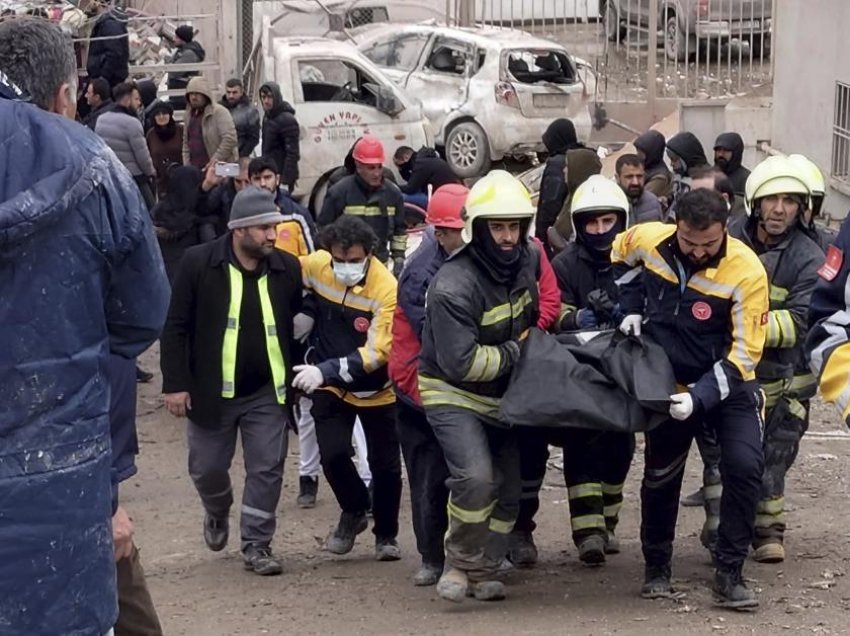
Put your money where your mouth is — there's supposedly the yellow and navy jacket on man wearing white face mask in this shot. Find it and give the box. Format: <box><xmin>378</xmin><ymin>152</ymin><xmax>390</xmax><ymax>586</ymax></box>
<box><xmin>301</xmin><ymin>250</ymin><xmax>397</xmax><ymax>406</ymax></box>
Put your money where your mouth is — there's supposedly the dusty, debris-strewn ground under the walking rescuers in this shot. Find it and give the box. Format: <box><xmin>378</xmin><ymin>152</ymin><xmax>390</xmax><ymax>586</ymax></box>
<box><xmin>129</xmin><ymin>351</ymin><xmax>850</xmax><ymax>636</ymax></box>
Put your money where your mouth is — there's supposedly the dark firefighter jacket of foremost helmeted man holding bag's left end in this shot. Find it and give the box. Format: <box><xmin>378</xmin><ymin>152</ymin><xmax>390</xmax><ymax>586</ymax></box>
<box><xmin>419</xmin><ymin>244</ymin><xmax>540</xmax><ymax>422</ymax></box>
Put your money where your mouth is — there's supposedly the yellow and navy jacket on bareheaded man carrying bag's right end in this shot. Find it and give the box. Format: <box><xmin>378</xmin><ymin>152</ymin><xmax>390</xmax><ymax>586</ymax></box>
<box><xmin>611</xmin><ymin>223</ymin><xmax>769</xmax><ymax>410</ymax></box>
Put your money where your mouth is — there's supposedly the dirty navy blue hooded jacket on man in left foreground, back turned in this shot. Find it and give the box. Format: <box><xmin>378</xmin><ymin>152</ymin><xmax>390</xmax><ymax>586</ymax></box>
<box><xmin>0</xmin><ymin>99</ymin><xmax>168</xmax><ymax>636</ymax></box>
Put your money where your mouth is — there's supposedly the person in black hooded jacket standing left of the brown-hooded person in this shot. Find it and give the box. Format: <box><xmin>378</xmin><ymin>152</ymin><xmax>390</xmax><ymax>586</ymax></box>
<box><xmin>534</xmin><ymin>118</ymin><xmax>584</xmax><ymax>248</ymax></box>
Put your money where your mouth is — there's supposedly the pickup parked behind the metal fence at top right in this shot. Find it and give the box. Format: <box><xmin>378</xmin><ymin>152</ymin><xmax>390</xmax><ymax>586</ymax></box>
<box><xmin>600</xmin><ymin>0</ymin><xmax>772</xmax><ymax>61</ymax></box>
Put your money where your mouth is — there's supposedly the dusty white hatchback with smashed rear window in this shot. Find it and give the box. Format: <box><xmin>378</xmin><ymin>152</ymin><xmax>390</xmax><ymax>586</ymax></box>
<box><xmin>351</xmin><ymin>24</ymin><xmax>593</xmax><ymax>178</ymax></box>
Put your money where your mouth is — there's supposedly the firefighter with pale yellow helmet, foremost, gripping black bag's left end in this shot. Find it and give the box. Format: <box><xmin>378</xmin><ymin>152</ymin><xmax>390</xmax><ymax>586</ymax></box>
<box><xmin>419</xmin><ymin>170</ymin><xmax>540</xmax><ymax>602</ymax></box>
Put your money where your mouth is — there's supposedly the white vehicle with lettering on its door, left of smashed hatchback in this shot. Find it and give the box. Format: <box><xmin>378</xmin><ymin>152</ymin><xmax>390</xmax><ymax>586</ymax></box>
<box><xmin>263</xmin><ymin>37</ymin><xmax>433</xmax><ymax>210</ymax></box>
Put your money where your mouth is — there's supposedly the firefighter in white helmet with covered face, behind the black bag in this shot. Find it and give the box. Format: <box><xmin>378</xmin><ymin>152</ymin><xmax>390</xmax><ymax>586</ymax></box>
<box><xmin>508</xmin><ymin>175</ymin><xmax>634</xmax><ymax>567</ymax></box>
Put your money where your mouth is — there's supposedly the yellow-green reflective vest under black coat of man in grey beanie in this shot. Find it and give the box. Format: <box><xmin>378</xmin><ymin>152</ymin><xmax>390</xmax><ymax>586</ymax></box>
<box><xmin>221</xmin><ymin>265</ymin><xmax>286</xmax><ymax>404</ymax></box>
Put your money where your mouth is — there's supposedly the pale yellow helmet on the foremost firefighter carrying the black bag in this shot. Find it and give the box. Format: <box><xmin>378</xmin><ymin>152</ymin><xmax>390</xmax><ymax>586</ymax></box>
<box><xmin>461</xmin><ymin>170</ymin><xmax>535</xmax><ymax>243</ymax></box>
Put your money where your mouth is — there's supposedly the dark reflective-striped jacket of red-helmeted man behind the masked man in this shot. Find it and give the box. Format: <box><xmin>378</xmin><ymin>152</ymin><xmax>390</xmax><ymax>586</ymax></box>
<box><xmin>317</xmin><ymin>174</ymin><xmax>407</xmax><ymax>262</ymax></box>
